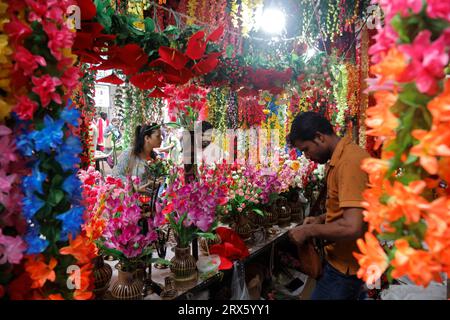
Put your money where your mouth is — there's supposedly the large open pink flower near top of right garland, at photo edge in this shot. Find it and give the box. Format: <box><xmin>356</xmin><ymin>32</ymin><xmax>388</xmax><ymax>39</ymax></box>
<box><xmin>399</xmin><ymin>30</ymin><xmax>449</xmax><ymax>94</ymax></box>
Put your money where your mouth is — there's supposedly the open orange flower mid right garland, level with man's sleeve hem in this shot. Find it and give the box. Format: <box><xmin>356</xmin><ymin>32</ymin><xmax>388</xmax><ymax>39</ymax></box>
<box><xmin>385</xmin><ymin>180</ymin><xmax>428</xmax><ymax>223</ymax></box>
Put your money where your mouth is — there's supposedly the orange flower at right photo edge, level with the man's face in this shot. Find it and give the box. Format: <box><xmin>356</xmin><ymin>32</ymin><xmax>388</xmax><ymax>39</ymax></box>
<box><xmin>410</xmin><ymin>125</ymin><xmax>450</xmax><ymax>174</ymax></box>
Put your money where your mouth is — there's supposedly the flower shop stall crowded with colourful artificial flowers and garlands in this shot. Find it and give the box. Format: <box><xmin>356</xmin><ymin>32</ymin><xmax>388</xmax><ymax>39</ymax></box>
<box><xmin>0</xmin><ymin>0</ymin><xmax>450</xmax><ymax>300</ymax></box>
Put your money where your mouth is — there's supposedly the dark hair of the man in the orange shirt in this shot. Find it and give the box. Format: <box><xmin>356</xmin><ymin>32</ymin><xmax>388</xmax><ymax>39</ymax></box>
<box><xmin>289</xmin><ymin>112</ymin><xmax>334</xmax><ymax>145</ymax></box>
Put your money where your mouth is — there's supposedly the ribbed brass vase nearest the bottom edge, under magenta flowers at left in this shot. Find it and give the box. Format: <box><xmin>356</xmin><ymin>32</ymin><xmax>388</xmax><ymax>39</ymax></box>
<box><xmin>111</xmin><ymin>269</ymin><xmax>143</xmax><ymax>300</ymax></box>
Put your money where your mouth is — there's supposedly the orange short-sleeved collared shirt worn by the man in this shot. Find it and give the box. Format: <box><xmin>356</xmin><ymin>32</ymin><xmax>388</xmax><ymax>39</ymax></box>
<box><xmin>325</xmin><ymin>136</ymin><xmax>370</xmax><ymax>275</ymax></box>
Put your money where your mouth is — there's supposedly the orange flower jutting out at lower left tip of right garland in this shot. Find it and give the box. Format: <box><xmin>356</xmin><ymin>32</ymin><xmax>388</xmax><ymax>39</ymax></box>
<box><xmin>353</xmin><ymin>232</ymin><xmax>389</xmax><ymax>284</ymax></box>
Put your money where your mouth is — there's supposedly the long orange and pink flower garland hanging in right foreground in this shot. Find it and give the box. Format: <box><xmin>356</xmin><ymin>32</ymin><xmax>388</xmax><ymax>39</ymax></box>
<box><xmin>355</xmin><ymin>1</ymin><xmax>450</xmax><ymax>286</ymax></box>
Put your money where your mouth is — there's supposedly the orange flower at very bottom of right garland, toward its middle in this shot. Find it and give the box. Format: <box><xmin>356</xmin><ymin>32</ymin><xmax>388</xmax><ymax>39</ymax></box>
<box><xmin>391</xmin><ymin>239</ymin><xmax>442</xmax><ymax>287</ymax></box>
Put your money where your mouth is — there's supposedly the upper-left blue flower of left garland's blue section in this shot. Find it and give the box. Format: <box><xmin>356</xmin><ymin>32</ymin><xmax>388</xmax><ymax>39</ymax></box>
<box><xmin>34</xmin><ymin>115</ymin><xmax>64</xmax><ymax>152</ymax></box>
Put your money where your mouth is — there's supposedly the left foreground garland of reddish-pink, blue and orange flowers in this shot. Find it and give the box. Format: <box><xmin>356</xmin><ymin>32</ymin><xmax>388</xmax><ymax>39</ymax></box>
<box><xmin>4</xmin><ymin>0</ymin><xmax>96</xmax><ymax>299</ymax></box>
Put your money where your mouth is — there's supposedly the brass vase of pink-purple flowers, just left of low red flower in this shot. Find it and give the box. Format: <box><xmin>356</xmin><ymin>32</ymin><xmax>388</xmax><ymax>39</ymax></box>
<box><xmin>170</xmin><ymin>247</ymin><xmax>197</xmax><ymax>281</ymax></box>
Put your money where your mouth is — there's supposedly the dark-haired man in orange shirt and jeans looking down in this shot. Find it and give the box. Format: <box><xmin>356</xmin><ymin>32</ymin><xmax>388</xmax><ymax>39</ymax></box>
<box><xmin>289</xmin><ymin>112</ymin><xmax>369</xmax><ymax>300</ymax></box>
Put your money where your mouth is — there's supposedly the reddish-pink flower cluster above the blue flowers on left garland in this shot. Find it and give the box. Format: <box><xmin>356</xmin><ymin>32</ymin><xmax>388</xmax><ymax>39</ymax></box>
<box><xmin>4</xmin><ymin>0</ymin><xmax>79</xmax><ymax>120</ymax></box>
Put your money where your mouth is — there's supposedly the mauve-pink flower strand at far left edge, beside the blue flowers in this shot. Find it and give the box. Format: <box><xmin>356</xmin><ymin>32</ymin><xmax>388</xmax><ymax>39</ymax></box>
<box><xmin>0</xmin><ymin>125</ymin><xmax>26</xmax><ymax>264</ymax></box>
